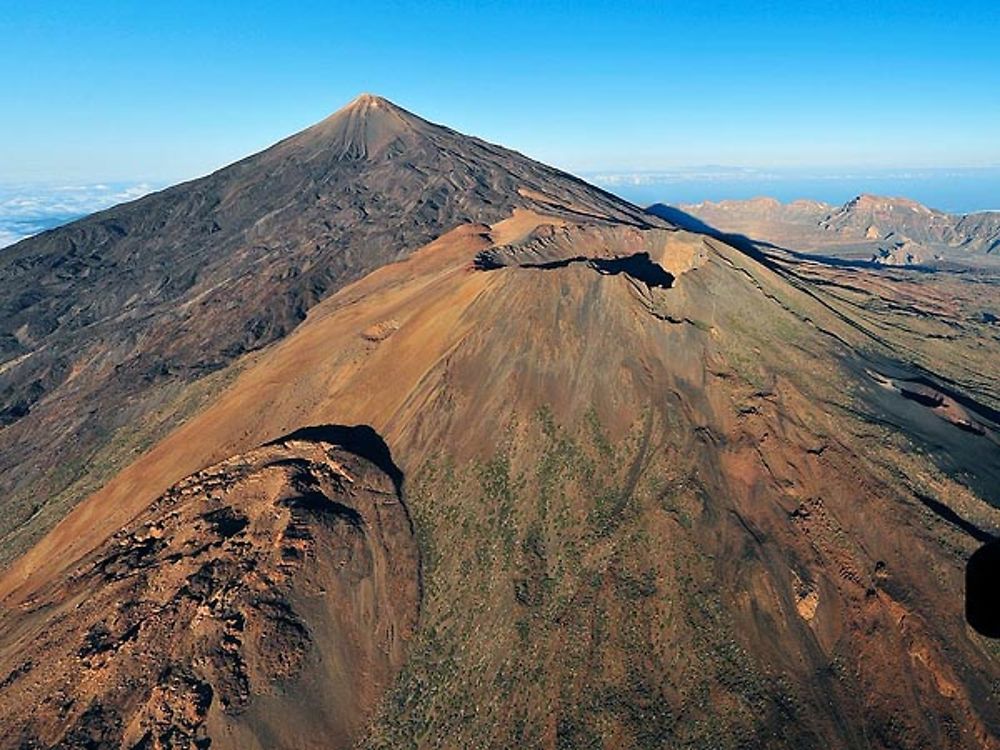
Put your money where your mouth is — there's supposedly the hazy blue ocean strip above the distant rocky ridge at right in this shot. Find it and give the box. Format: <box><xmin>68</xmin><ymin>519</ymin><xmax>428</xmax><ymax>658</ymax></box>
<box><xmin>581</xmin><ymin>166</ymin><xmax>1000</xmax><ymax>213</ymax></box>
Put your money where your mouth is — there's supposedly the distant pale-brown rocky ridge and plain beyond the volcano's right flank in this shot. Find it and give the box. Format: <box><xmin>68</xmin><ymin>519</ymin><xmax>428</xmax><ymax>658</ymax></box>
<box><xmin>676</xmin><ymin>195</ymin><xmax>1000</xmax><ymax>268</ymax></box>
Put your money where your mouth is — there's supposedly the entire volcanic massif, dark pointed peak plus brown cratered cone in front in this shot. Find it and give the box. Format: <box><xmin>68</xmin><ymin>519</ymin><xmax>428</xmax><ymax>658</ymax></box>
<box><xmin>0</xmin><ymin>96</ymin><xmax>1000</xmax><ymax>748</ymax></box>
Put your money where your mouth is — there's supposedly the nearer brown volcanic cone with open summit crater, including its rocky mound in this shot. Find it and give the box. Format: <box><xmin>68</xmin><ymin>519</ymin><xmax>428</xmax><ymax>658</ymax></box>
<box><xmin>0</xmin><ymin>138</ymin><xmax>1000</xmax><ymax>748</ymax></box>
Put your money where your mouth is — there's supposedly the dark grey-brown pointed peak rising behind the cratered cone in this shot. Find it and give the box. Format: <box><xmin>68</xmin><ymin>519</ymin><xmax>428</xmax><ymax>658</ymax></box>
<box><xmin>0</xmin><ymin>95</ymin><xmax>655</xmax><ymax>560</ymax></box>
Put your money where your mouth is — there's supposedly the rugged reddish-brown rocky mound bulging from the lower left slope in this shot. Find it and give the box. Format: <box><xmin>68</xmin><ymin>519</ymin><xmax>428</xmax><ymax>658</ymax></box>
<box><xmin>0</xmin><ymin>427</ymin><xmax>420</xmax><ymax>748</ymax></box>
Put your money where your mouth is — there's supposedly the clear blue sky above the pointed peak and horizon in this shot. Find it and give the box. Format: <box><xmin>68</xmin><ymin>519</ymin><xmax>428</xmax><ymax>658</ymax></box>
<box><xmin>0</xmin><ymin>0</ymin><xmax>1000</xmax><ymax>182</ymax></box>
